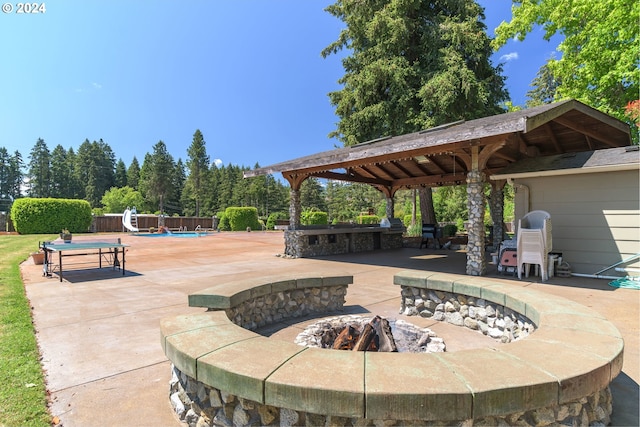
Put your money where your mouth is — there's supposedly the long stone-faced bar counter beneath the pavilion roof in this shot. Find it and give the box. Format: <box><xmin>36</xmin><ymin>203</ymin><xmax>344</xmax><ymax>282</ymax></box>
<box><xmin>284</xmin><ymin>225</ymin><xmax>404</xmax><ymax>258</ymax></box>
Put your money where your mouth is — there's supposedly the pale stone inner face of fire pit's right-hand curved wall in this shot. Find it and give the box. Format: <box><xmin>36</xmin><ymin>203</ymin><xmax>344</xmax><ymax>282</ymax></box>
<box><xmin>400</xmin><ymin>286</ymin><xmax>535</xmax><ymax>343</ymax></box>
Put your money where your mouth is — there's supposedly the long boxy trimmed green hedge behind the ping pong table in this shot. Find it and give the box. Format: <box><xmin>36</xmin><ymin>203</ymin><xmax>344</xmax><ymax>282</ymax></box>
<box><xmin>11</xmin><ymin>198</ymin><xmax>92</xmax><ymax>234</ymax></box>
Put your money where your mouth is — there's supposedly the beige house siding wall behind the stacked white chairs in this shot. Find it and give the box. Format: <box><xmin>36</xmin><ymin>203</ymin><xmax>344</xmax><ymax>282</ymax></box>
<box><xmin>514</xmin><ymin>169</ymin><xmax>640</xmax><ymax>276</ymax></box>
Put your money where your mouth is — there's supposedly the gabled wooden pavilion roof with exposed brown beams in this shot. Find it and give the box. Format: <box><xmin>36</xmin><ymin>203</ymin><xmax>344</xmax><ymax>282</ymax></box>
<box><xmin>245</xmin><ymin>100</ymin><xmax>631</xmax><ymax>194</ymax></box>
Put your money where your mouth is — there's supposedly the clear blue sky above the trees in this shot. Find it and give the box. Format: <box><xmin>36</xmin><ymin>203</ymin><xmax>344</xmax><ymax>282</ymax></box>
<box><xmin>0</xmin><ymin>0</ymin><xmax>558</xmax><ymax>171</ymax></box>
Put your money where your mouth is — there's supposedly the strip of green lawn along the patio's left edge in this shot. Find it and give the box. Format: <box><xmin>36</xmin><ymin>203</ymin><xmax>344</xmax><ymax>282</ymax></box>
<box><xmin>0</xmin><ymin>235</ymin><xmax>52</xmax><ymax>427</ymax></box>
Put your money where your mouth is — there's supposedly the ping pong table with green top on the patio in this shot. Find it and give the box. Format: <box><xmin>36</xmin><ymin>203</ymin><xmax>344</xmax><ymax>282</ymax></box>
<box><xmin>40</xmin><ymin>239</ymin><xmax>129</xmax><ymax>282</ymax></box>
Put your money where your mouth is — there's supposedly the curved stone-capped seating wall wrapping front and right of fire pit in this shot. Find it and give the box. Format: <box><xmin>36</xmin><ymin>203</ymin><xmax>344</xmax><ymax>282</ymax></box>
<box><xmin>161</xmin><ymin>271</ymin><xmax>623</xmax><ymax>426</ymax></box>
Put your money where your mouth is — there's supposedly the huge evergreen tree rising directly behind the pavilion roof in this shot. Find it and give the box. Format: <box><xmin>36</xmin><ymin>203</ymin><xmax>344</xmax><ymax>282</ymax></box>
<box><xmin>322</xmin><ymin>0</ymin><xmax>507</xmax><ymax>221</ymax></box>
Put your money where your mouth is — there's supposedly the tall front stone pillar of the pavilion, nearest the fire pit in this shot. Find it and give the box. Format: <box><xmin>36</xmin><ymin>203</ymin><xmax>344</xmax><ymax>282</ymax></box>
<box><xmin>467</xmin><ymin>170</ymin><xmax>487</xmax><ymax>276</ymax></box>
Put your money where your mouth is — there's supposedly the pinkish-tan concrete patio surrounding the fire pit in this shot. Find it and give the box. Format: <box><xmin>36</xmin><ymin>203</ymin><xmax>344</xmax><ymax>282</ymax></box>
<box><xmin>22</xmin><ymin>232</ymin><xmax>640</xmax><ymax>427</ymax></box>
